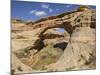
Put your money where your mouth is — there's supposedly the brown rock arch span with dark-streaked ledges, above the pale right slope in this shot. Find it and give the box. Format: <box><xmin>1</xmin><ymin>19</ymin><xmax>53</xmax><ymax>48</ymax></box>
<box><xmin>33</xmin><ymin>7</ymin><xmax>95</xmax><ymax>51</ymax></box>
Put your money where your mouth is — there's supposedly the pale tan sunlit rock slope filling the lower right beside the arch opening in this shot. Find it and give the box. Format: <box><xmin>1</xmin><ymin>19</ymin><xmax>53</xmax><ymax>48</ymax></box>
<box><xmin>48</xmin><ymin>27</ymin><xmax>96</xmax><ymax>71</ymax></box>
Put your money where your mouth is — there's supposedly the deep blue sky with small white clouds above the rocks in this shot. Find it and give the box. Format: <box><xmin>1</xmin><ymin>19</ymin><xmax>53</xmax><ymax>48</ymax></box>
<box><xmin>11</xmin><ymin>0</ymin><xmax>95</xmax><ymax>21</ymax></box>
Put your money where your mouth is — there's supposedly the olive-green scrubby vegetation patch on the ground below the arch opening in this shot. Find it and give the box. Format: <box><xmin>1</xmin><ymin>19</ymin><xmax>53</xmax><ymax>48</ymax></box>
<box><xmin>32</xmin><ymin>45</ymin><xmax>62</xmax><ymax>70</ymax></box>
